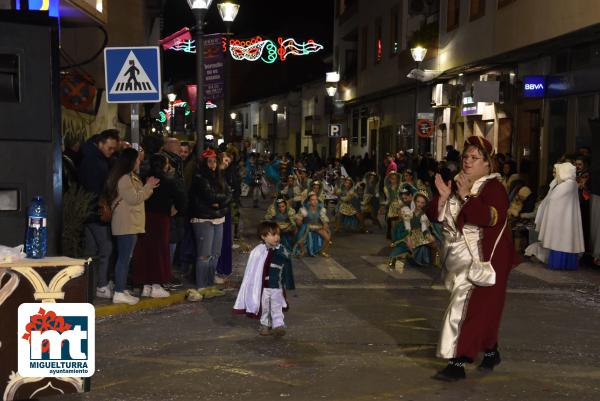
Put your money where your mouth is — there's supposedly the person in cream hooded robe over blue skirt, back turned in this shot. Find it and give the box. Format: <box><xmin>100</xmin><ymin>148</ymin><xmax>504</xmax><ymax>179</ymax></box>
<box><xmin>525</xmin><ymin>163</ymin><xmax>585</xmax><ymax>270</ymax></box>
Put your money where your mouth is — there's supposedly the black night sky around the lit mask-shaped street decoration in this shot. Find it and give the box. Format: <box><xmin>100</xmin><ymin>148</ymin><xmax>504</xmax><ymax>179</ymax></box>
<box><xmin>162</xmin><ymin>0</ymin><xmax>334</xmax><ymax>104</ymax></box>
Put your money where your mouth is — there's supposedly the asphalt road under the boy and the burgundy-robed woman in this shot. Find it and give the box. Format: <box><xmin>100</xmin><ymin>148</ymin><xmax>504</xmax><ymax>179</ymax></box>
<box><xmin>61</xmin><ymin>203</ymin><xmax>600</xmax><ymax>401</ymax></box>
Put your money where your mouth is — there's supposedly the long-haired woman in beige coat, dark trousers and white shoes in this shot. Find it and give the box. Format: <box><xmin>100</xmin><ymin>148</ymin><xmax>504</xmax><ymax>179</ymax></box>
<box><xmin>106</xmin><ymin>148</ymin><xmax>160</xmax><ymax>305</ymax></box>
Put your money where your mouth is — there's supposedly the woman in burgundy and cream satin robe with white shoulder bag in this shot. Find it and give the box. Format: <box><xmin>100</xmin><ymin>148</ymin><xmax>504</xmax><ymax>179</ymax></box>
<box><xmin>427</xmin><ymin>136</ymin><xmax>516</xmax><ymax>381</ymax></box>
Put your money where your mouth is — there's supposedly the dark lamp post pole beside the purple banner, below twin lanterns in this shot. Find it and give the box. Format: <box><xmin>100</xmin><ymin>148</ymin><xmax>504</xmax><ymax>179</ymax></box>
<box><xmin>194</xmin><ymin>10</ymin><xmax>206</xmax><ymax>156</ymax></box>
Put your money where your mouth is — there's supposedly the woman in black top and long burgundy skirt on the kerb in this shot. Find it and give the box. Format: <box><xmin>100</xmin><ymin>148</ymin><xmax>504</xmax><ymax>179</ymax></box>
<box><xmin>133</xmin><ymin>153</ymin><xmax>185</xmax><ymax>298</ymax></box>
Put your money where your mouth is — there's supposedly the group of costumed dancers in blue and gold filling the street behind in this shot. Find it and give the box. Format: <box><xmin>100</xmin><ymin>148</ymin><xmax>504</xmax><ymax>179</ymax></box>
<box><xmin>265</xmin><ymin>164</ymin><xmax>441</xmax><ymax>272</ymax></box>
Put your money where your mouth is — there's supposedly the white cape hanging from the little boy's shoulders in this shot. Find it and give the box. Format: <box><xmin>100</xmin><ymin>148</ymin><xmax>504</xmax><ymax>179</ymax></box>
<box><xmin>233</xmin><ymin>244</ymin><xmax>269</xmax><ymax>315</ymax></box>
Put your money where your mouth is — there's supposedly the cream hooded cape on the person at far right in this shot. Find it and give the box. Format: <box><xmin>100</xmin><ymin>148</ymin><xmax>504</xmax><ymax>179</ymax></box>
<box><xmin>535</xmin><ymin>163</ymin><xmax>585</xmax><ymax>253</ymax></box>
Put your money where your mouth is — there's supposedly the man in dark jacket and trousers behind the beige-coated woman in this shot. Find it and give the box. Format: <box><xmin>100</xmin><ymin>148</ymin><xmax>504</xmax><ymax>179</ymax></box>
<box><xmin>79</xmin><ymin>129</ymin><xmax>119</xmax><ymax>298</ymax></box>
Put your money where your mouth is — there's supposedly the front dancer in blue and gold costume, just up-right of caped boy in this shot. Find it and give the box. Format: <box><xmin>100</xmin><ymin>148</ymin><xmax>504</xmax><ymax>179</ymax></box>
<box><xmin>293</xmin><ymin>192</ymin><xmax>331</xmax><ymax>257</ymax></box>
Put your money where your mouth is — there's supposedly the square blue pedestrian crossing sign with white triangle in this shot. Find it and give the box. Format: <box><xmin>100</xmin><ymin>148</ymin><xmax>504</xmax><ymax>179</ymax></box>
<box><xmin>104</xmin><ymin>46</ymin><xmax>162</xmax><ymax>103</ymax></box>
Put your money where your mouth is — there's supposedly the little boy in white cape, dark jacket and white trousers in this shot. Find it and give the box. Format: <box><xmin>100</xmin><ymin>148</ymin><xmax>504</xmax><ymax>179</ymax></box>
<box><xmin>233</xmin><ymin>221</ymin><xmax>295</xmax><ymax>337</ymax></box>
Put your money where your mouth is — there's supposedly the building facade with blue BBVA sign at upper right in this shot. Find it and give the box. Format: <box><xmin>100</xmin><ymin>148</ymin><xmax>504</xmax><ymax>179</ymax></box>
<box><xmin>436</xmin><ymin>0</ymin><xmax>600</xmax><ymax>186</ymax></box>
